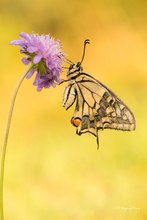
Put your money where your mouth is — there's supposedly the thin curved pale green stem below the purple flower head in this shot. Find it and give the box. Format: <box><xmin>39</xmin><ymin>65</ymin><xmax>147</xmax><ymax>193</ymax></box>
<box><xmin>0</xmin><ymin>65</ymin><xmax>33</xmax><ymax>220</ymax></box>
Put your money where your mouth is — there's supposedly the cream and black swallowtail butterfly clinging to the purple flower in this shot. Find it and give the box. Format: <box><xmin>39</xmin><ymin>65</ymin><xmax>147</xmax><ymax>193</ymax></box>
<box><xmin>61</xmin><ymin>40</ymin><xmax>136</xmax><ymax>147</ymax></box>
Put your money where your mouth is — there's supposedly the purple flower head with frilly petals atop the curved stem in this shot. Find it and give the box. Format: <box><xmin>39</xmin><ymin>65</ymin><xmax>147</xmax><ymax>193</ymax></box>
<box><xmin>10</xmin><ymin>33</ymin><xmax>64</xmax><ymax>91</ymax></box>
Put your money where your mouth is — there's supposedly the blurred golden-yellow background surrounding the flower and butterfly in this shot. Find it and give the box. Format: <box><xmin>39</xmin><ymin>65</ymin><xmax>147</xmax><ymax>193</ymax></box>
<box><xmin>0</xmin><ymin>0</ymin><xmax>147</xmax><ymax>220</ymax></box>
